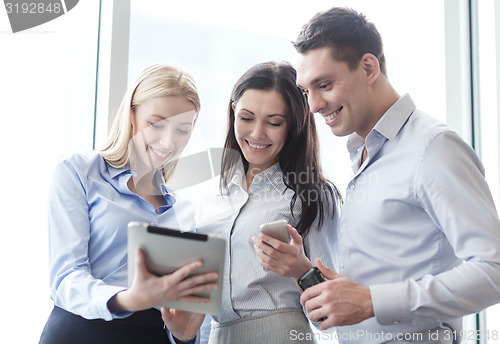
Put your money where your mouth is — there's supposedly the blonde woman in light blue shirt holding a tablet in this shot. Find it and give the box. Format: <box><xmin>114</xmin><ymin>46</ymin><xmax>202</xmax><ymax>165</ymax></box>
<box><xmin>40</xmin><ymin>65</ymin><xmax>217</xmax><ymax>344</ymax></box>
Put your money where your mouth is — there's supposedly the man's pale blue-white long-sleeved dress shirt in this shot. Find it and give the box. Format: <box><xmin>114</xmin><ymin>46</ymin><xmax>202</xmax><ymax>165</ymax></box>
<box><xmin>335</xmin><ymin>95</ymin><xmax>500</xmax><ymax>343</ymax></box>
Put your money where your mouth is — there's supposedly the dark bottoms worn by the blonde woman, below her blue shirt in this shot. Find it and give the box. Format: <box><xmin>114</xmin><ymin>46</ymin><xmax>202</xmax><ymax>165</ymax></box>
<box><xmin>39</xmin><ymin>307</ymin><xmax>170</xmax><ymax>344</ymax></box>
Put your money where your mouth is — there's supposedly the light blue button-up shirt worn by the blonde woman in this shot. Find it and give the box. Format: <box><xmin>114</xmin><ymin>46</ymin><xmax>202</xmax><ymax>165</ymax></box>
<box><xmin>49</xmin><ymin>152</ymin><xmax>194</xmax><ymax>320</ymax></box>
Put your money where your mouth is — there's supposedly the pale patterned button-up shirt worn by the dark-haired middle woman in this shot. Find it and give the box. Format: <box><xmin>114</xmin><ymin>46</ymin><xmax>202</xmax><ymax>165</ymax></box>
<box><xmin>197</xmin><ymin>163</ymin><xmax>340</xmax><ymax>326</ymax></box>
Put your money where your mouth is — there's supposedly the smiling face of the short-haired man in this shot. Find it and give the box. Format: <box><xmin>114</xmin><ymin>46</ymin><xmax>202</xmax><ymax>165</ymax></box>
<box><xmin>297</xmin><ymin>47</ymin><xmax>373</xmax><ymax>138</ymax></box>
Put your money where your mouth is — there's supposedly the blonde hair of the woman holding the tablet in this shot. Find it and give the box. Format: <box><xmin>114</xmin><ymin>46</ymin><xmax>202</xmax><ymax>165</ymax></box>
<box><xmin>100</xmin><ymin>64</ymin><xmax>200</xmax><ymax>173</ymax></box>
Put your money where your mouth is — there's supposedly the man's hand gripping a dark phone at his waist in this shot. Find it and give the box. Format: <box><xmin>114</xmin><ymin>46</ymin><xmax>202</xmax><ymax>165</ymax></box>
<box><xmin>300</xmin><ymin>259</ymin><xmax>374</xmax><ymax>330</ymax></box>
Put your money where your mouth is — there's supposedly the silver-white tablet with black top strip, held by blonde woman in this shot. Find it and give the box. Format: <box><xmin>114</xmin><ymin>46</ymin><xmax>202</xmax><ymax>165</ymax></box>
<box><xmin>127</xmin><ymin>222</ymin><xmax>226</xmax><ymax>315</ymax></box>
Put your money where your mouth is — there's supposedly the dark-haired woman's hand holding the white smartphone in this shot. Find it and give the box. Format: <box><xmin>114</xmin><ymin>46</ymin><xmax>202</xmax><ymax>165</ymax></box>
<box><xmin>252</xmin><ymin>225</ymin><xmax>313</xmax><ymax>281</ymax></box>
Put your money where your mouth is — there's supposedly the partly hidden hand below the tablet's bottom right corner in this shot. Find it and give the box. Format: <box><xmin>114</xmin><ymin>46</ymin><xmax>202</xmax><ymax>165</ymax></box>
<box><xmin>161</xmin><ymin>307</ymin><xmax>205</xmax><ymax>342</ymax></box>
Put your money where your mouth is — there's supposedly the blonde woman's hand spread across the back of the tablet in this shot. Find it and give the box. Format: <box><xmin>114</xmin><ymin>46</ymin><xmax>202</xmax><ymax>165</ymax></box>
<box><xmin>108</xmin><ymin>249</ymin><xmax>217</xmax><ymax>312</ymax></box>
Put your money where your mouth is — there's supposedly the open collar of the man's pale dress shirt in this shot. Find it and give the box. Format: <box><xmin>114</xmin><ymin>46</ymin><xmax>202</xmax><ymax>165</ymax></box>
<box><xmin>347</xmin><ymin>94</ymin><xmax>416</xmax><ymax>154</ymax></box>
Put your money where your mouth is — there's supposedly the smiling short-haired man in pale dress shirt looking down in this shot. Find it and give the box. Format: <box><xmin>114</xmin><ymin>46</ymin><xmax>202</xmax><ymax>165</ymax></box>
<box><xmin>294</xmin><ymin>8</ymin><xmax>500</xmax><ymax>343</ymax></box>
